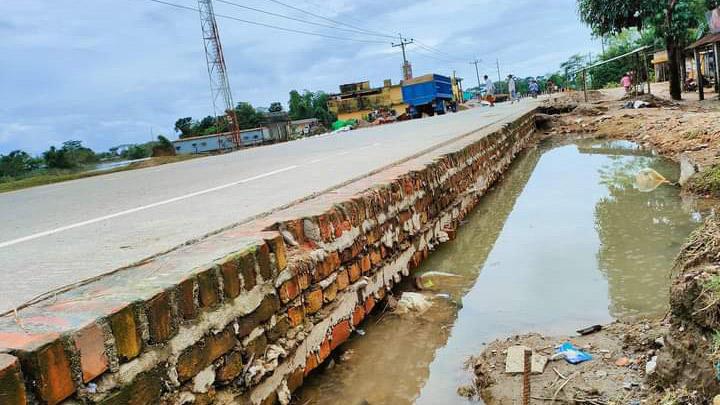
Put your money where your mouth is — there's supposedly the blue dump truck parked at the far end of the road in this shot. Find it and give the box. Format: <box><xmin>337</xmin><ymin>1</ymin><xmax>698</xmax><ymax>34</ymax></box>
<box><xmin>402</xmin><ymin>74</ymin><xmax>455</xmax><ymax>118</ymax></box>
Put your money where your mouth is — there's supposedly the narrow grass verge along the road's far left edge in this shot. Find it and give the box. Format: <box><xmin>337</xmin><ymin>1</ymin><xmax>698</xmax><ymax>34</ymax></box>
<box><xmin>0</xmin><ymin>155</ymin><xmax>202</xmax><ymax>193</ymax></box>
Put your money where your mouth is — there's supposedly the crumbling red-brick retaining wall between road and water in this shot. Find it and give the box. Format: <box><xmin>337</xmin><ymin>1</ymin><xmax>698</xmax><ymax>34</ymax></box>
<box><xmin>0</xmin><ymin>113</ymin><xmax>534</xmax><ymax>405</ymax></box>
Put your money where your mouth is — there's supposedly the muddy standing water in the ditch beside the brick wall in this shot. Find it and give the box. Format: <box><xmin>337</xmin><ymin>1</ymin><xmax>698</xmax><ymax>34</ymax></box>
<box><xmin>297</xmin><ymin>141</ymin><xmax>700</xmax><ymax>405</ymax></box>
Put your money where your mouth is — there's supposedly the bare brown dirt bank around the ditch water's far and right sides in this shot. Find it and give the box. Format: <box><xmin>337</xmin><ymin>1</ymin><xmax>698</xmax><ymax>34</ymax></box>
<box><xmin>459</xmin><ymin>93</ymin><xmax>720</xmax><ymax>405</ymax></box>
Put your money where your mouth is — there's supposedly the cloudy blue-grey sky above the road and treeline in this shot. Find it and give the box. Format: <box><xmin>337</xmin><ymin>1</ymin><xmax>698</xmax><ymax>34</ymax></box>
<box><xmin>0</xmin><ymin>0</ymin><xmax>600</xmax><ymax>154</ymax></box>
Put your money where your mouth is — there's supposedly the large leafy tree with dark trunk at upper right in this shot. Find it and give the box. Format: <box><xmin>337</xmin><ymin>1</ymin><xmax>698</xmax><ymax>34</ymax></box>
<box><xmin>578</xmin><ymin>0</ymin><xmax>718</xmax><ymax>100</ymax></box>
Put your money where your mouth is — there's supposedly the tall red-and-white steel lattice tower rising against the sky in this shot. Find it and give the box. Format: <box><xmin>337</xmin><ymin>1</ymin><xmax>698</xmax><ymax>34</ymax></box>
<box><xmin>198</xmin><ymin>0</ymin><xmax>241</xmax><ymax>148</ymax></box>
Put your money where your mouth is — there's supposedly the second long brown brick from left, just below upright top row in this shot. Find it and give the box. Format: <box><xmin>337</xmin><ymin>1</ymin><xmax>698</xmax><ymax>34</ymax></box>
<box><xmin>176</xmin><ymin>327</ymin><xmax>237</xmax><ymax>382</ymax></box>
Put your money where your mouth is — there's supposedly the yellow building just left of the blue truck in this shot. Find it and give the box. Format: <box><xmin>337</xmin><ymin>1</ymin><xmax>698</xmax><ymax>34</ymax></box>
<box><xmin>328</xmin><ymin>80</ymin><xmax>407</xmax><ymax>120</ymax></box>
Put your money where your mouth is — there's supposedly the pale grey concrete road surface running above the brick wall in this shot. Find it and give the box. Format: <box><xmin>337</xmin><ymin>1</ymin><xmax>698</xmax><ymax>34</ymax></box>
<box><xmin>0</xmin><ymin>100</ymin><xmax>537</xmax><ymax>311</ymax></box>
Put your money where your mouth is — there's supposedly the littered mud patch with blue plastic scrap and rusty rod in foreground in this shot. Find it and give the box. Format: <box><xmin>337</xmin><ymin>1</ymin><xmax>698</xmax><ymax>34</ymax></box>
<box><xmin>458</xmin><ymin>323</ymin><xmax>667</xmax><ymax>405</ymax></box>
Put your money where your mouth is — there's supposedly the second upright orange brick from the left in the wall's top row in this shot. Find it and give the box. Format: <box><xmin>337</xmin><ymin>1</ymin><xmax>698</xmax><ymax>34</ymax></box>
<box><xmin>18</xmin><ymin>339</ymin><xmax>75</xmax><ymax>405</ymax></box>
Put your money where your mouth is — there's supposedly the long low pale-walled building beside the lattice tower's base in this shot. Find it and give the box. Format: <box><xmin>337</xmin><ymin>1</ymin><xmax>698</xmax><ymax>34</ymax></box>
<box><xmin>173</xmin><ymin>128</ymin><xmax>270</xmax><ymax>155</ymax></box>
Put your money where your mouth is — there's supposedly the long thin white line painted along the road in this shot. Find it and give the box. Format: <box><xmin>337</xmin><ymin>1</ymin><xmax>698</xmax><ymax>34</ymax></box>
<box><xmin>0</xmin><ymin>165</ymin><xmax>298</xmax><ymax>248</ymax></box>
